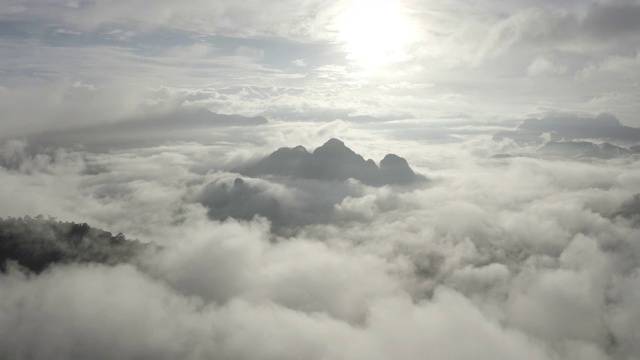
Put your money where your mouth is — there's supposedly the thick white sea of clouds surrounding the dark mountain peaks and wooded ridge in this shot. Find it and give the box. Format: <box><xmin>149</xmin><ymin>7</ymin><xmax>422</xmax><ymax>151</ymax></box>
<box><xmin>0</xmin><ymin>119</ymin><xmax>640</xmax><ymax>359</ymax></box>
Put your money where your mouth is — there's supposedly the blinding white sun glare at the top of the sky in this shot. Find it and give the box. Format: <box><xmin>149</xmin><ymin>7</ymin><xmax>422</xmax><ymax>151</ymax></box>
<box><xmin>339</xmin><ymin>0</ymin><xmax>417</xmax><ymax>70</ymax></box>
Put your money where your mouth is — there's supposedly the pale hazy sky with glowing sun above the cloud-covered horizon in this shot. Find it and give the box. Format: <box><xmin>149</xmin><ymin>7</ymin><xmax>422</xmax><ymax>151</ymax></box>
<box><xmin>0</xmin><ymin>0</ymin><xmax>640</xmax><ymax>136</ymax></box>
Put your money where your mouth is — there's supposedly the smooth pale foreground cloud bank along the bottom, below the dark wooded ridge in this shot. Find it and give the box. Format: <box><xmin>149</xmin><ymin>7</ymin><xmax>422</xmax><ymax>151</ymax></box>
<box><xmin>0</xmin><ymin>266</ymin><xmax>556</xmax><ymax>359</ymax></box>
